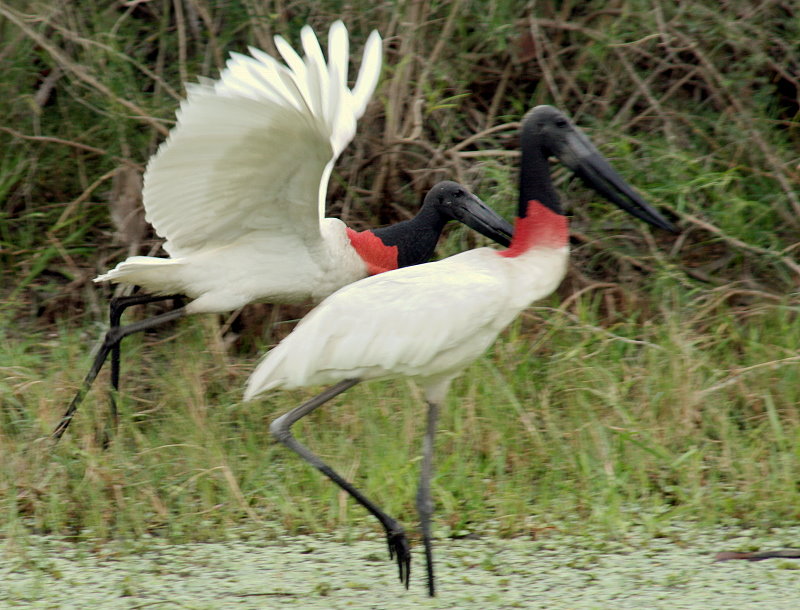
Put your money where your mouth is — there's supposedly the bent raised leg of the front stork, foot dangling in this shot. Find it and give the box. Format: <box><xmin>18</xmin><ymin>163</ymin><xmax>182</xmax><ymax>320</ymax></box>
<box><xmin>269</xmin><ymin>379</ymin><xmax>411</xmax><ymax>589</ymax></box>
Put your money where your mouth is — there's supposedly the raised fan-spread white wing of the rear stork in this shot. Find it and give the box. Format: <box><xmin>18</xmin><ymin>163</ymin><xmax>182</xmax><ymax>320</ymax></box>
<box><xmin>143</xmin><ymin>21</ymin><xmax>381</xmax><ymax>258</ymax></box>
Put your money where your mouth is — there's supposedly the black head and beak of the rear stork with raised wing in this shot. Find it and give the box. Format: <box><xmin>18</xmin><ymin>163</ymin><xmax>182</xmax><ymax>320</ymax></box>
<box><xmin>423</xmin><ymin>180</ymin><xmax>514</xmax><ymax>246</ymax></box>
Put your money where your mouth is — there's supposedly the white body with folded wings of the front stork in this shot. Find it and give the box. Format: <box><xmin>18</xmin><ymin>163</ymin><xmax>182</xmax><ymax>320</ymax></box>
<box><xmin>245</xmin><ymin>241</ymin><xmax>569</xmax><ymax>403</ymax></box>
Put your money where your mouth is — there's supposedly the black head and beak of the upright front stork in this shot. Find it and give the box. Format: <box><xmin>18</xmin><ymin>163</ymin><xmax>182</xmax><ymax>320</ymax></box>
<box><xmin>521</xmin><ymin>106</ymin><xmax>678</xmax><ymax>233</ymax></box>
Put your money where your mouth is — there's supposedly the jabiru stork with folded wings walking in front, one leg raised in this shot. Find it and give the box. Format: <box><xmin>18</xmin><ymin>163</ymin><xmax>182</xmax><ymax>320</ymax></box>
<box><xmin>244</xmin><ymin>106</ymin><xmax>676</xmax><ymax>596</ymax></box>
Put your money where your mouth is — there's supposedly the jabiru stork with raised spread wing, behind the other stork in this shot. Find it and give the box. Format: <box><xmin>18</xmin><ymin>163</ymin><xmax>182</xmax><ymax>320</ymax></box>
<box><xmin>52</xmin><ymin>21</ymin><xmax>513</xmax><ymax>440</ymax></box>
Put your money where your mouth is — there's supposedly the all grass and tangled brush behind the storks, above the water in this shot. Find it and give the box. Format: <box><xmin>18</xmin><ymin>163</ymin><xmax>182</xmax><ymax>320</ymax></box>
<box><xmin>0</xmin><ymin>0</ymin><xmax>800</xmax><ymax>540</ymax></box>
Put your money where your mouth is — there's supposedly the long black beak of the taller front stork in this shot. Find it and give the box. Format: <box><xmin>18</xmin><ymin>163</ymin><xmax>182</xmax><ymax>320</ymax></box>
<box><xmin>552</xmin><ymin>125</ymin><xmax>678</xmax><ymax>233</ymax></box>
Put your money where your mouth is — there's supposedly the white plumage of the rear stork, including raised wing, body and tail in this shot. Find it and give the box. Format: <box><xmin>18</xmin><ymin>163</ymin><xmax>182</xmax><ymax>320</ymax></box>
<box><xmin>95</xmin><ymin>21</ymin><xmax>381</xmax><ymax>312</ymax></box>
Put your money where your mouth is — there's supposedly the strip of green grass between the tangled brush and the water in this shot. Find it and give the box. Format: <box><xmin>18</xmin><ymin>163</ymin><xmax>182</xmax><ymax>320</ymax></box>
<box><xmin>0</xmin><ymin>282</ymin><xmax>800</xmax><ymax>540</ymax></box>
